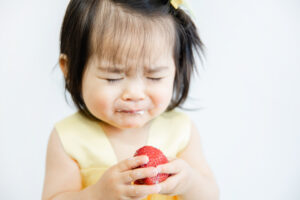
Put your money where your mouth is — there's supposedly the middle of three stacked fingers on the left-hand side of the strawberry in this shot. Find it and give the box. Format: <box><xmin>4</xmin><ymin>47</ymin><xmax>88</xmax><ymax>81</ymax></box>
<box><xmin>122</xmin><ymin>167</ymin><xmax>158</xmax><ymax>183</ymax></box>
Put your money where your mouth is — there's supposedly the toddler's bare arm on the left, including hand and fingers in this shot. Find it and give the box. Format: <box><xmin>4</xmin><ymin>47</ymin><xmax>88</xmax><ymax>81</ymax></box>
<box><xmin>42</xmin><ymin>130</ymin><xmax>160</xmax><ymax>200</ymax></box>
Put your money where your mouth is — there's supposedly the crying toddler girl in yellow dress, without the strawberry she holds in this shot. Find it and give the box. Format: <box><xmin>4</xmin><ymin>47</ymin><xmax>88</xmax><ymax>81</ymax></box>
<box><xmin>42</xmin><ymin>0</ymin><xmax>218</xmax><ymax>200</ymax></box>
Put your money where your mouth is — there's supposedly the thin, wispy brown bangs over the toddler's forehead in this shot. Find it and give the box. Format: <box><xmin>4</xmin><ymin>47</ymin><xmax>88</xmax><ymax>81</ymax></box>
<box><xmin>90</xmin><ymin>1</ymin><xmax>175</xmax><ymax>69</ymax></box>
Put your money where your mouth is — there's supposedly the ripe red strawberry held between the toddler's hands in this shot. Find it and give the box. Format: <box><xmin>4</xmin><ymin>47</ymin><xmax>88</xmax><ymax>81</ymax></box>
<box><xmin>134</xmin><ymin>146</ymin><xmax>169</xmax><ymax>185</ymax></box>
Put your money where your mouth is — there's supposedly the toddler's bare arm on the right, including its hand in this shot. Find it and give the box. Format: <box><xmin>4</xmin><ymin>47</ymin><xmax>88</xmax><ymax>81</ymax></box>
<box><xmin>157</xmin><ymin>121</ymin><xmax>219</xmax><ymax>200</ymax></box>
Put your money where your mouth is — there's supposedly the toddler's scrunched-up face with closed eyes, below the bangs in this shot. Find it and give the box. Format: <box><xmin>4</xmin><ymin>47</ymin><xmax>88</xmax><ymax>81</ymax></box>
<box><xmin>82</xmin><ymin>48</ymin><xmax>175</xmax><ymax>129</ymax></box>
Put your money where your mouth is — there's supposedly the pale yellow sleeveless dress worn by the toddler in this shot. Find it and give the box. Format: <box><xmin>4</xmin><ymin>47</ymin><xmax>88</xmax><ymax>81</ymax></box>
<box><xmin>55</xmin><ymin>110</ymin><xmax>190</xmax><ymax>200</ymax></box>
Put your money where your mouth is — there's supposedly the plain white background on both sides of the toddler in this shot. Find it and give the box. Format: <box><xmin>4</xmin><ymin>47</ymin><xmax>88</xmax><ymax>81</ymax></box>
<box><xmin>0</xmin><ymin>0</ymin><xmax>300</xmax><ymax>200</ymax></box>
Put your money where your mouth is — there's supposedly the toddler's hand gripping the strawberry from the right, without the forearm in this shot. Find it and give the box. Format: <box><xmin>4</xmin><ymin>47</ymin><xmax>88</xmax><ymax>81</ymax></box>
<box><xmin>157</xmin><ymin>158</ymin><xmax>194</xmax><ymax>196</ymax></box>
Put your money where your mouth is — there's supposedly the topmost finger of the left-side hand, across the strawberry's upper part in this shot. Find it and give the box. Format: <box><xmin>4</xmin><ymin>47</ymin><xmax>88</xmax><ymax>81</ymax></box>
<box><xmin>117</xmin><ymin>156</ymin><xmax>149</xmax><ymax>172</ymax></box>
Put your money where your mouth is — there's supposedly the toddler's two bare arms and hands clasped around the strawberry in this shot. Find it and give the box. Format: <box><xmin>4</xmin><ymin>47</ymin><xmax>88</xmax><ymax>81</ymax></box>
<box><xmin>42</xmin><ymin>125</ymin><xmax>219</xmax><ymax>200</ymax></box>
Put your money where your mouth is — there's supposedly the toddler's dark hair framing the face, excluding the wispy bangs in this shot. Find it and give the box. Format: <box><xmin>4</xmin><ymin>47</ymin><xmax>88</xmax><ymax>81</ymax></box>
<box><xmin>60</xmin><ymin>0</ymin><xmax>204</xmax><ymax>120</ymax></box>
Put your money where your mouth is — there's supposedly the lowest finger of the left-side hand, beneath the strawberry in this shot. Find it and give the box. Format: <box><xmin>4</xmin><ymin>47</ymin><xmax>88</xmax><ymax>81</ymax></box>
<box><xmin>126</xmin><ymin>185</ymin><xmax>161</xmax><ymax>197</ymax></box>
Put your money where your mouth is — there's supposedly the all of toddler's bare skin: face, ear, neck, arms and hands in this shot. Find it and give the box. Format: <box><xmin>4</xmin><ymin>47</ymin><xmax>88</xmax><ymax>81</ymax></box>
<box><xmin>42</xmin><ymin>32</ymin><xmax>219</xmax><ymax>200</ymax></box>
